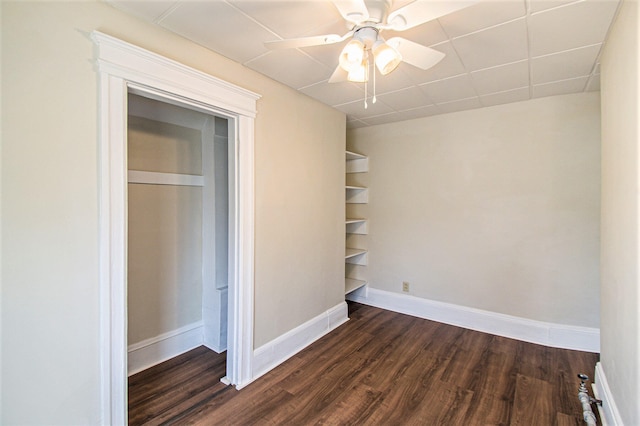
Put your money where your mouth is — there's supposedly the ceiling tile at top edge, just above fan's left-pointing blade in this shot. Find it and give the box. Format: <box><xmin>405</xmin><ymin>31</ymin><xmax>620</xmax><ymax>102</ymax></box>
<box><xmin>229</xmin><ymin>0</ymin><xmax>347</xmax><ymax>38</ymax></box>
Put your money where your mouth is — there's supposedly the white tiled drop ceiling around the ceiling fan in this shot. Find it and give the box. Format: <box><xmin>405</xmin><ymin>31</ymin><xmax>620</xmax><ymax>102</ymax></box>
<box><xmin>108</xmin><ymin>0</ymin><xmax>619</xmax><ymax>128</ymax></box>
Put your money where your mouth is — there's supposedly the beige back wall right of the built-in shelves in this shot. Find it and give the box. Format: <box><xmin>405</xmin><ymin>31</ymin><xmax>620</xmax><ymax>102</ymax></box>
<box><xmin>347</xmin><ymin>93</ymin><xmax>600</xmax><ymax>327</ymax></box>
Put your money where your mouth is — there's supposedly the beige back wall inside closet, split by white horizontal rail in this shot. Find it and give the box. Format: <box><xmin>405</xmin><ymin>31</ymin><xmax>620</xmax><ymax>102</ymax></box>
<box><xmin>127</xmin><ymin>116</ymin><xmax>203</xmax><ymax>345</ymax></box>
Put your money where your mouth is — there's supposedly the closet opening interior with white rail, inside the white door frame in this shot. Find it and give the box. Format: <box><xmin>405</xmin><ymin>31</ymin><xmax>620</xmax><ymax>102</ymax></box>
<box><xmin>127</xmin><ymin>89</ymin><xmax>234</xmax><ymax>378</ymax></box>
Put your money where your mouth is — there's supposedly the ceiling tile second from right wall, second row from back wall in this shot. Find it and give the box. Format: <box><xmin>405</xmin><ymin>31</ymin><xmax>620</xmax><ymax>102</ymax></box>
<box><xmin>471</xmin><ymin>61</ymin><xmax>529</xmax><ymax>96</ymax></box>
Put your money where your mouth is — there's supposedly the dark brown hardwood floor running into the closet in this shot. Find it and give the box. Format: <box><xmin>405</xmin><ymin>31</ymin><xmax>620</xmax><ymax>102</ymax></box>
<box><xmin>129</xmin><ymin>303</ymin><xmax>598</xmax><ymax>426</ymax></box>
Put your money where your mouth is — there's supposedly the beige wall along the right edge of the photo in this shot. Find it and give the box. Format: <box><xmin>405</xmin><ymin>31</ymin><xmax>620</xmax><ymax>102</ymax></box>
<box><xmin>600</xmin><ymin>1</ymin><xmax>640</xmax><ymax>425</ymax></box>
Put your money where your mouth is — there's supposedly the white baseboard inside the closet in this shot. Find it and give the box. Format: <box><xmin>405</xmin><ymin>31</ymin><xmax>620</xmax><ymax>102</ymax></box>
<box><xmin>127</xmin><ymin>321</ymin><xmax>203</xmax><ymax>376</ymax></box>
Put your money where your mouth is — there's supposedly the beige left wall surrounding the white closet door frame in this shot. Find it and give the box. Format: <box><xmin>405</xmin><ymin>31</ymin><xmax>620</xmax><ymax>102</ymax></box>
<box><xmin>0</xmin><ymin>1</ymin><xmax>345</xmax><ymax>425</ymax></box>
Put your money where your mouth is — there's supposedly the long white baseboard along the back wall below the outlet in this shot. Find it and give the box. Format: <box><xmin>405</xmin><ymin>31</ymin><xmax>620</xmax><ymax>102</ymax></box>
<box><xmin>348</xmin><ymin>288</ymin><xmax>600</xmax><ymax>352</ymax></box>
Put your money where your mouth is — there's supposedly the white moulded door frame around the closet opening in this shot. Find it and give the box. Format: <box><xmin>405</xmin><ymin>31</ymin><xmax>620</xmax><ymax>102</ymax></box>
<box><xmin>91</xmin><ymin>31</ymin><xmax>260</xmax><ymax>424</ymax></box>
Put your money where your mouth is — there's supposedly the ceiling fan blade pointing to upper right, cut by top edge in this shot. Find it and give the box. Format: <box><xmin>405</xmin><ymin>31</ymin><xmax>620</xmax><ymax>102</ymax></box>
<box><xmin>387</xmin><ymin>0</ymin><xmax>478</xmax><ymax>31</ymax></box>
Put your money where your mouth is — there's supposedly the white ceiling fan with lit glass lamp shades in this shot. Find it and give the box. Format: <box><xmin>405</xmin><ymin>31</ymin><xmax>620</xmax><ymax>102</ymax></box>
<box><xmin>265</xmin><ymin>0</ymin><xmax>477</xmax><ymax>84</ymax></box>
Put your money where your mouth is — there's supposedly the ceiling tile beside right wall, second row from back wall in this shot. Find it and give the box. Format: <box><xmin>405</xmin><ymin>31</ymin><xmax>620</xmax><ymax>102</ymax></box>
<box><xmin>531</xmin><ymin>44</ymin><xmax>600</xmax><ymax>84</ymax></box>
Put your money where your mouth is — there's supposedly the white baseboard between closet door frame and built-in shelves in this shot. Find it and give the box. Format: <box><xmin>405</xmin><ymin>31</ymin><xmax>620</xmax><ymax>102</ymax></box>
<box><xmin>251</xmin><ymin>302</ymin><xmax>349</xmax><ymax>380</ymax></box>
